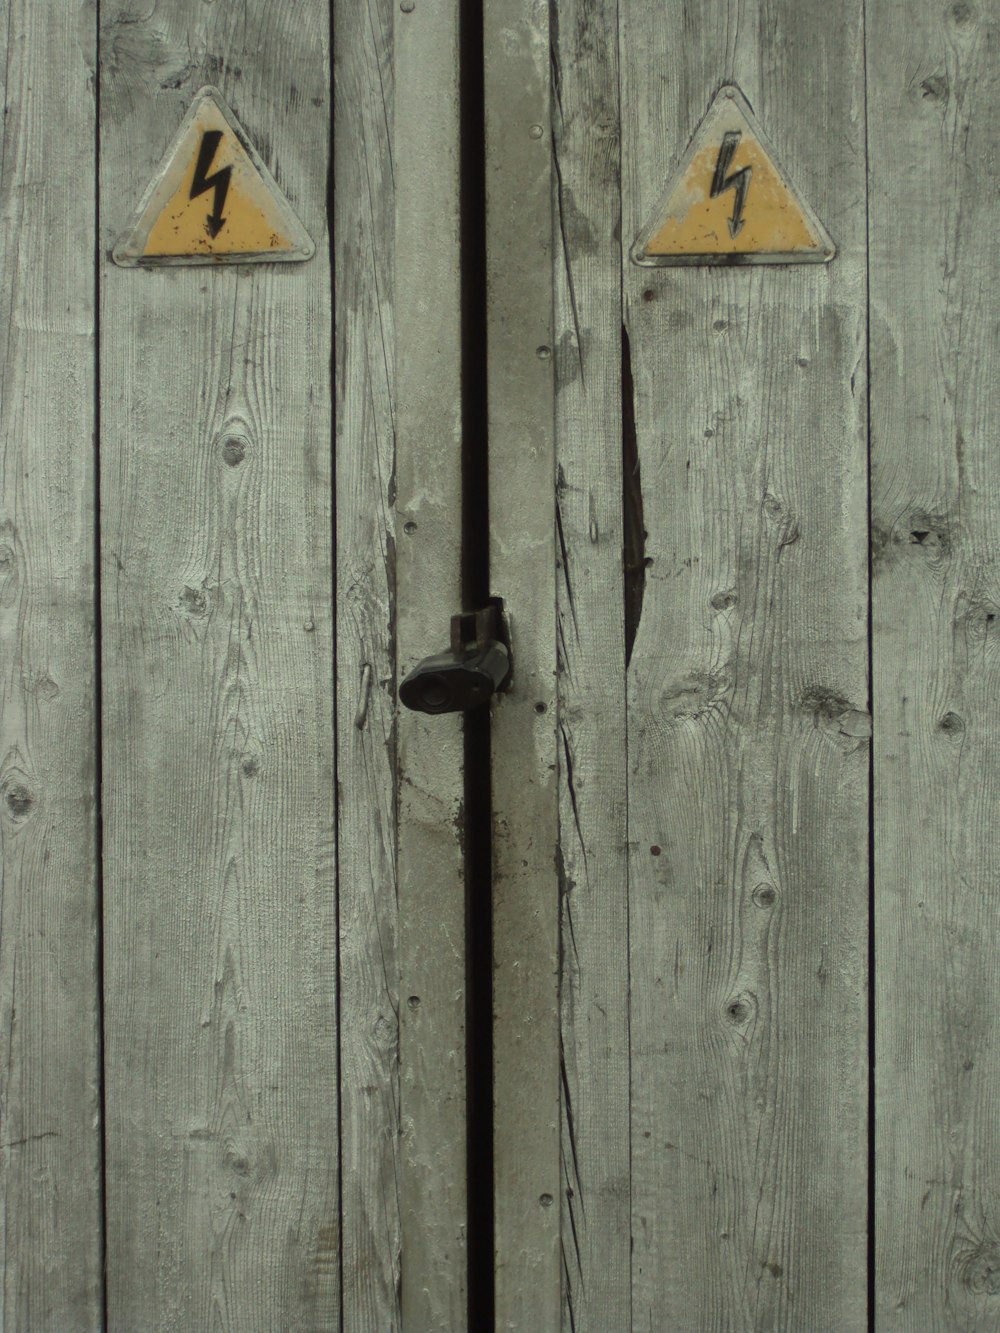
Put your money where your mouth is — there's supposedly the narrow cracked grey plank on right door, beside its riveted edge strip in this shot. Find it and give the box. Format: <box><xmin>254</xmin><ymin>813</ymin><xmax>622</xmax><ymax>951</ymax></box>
<box><xmin>552</xmin><ymin>0</ymin><xmax>631</xmax><ymax>1333</ymax></box>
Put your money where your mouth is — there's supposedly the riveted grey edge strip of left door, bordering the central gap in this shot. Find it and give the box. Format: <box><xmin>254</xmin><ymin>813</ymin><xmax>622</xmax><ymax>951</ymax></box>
<box><xmin>395</xmin><ymin>0</ymin><xmax>472</xmax><ymax>1333</ymax></box>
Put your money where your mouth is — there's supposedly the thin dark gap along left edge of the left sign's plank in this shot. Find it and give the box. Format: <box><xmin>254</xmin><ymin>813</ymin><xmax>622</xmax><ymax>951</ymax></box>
<box><xmin>92</xmin><ymin>0</ymin><xmax>108</xmax><ymax>1330</ymax></box>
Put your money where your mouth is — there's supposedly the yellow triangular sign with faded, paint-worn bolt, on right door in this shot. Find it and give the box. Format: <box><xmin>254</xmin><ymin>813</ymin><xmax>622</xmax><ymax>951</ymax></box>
<box><xmin>632</xmin><ymin>85</ymin><xmax>836</xmax><ymax>264</ymax></box>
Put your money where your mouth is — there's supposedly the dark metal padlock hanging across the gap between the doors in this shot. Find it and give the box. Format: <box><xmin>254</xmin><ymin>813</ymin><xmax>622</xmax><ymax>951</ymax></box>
<box><xmin>399</xmin><ymin>597</ymin><xmax>511</xmax><ymax>713</ymax></box>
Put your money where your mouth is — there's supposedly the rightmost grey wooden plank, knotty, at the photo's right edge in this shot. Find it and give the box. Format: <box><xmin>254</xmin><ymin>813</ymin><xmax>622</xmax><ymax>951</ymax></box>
<box><xmin>867</xmin><ymin>0</ymin><xmax>1000</xmax><ymax>1330</ymax></box>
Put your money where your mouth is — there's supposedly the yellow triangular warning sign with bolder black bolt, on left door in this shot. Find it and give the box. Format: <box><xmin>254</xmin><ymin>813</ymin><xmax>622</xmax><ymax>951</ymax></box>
<box><xmin>112</xmin><ymin>88</ymin><xmax>315</xmax><ymax>265</ymax></box>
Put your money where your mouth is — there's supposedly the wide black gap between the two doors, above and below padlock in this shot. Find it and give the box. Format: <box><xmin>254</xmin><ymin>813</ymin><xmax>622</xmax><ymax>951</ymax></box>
<box><xmin>460</xmin><ymin>0</ymin><xmax>493</xmax><ymax>1330</ymax></box>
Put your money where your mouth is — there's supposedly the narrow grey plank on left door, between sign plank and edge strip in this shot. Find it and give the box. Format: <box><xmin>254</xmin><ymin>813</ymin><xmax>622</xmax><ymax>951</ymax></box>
<box><xmin>333</xmin><ymin>0</ymin><xmax>401</xmax><ymax>1333</ymax></box>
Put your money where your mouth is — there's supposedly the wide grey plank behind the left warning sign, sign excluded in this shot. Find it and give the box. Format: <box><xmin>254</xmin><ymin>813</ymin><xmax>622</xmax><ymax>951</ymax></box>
<box><xmin>100</xmin><ymin>0</ymin><xmax>339</xmax><ymax>1329</ymax></box>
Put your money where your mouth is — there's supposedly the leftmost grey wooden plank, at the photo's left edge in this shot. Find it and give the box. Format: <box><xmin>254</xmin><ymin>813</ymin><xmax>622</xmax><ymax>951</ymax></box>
<box><xmin>0</xmin><ymin>0</ymin><xmax>101</xmax><ymax>1330</ymax></box>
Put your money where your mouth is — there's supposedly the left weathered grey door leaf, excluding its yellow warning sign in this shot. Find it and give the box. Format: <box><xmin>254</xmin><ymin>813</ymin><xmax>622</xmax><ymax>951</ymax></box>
<box><xmin>0</xmin><ymin>0</ymin><xmax>465</xmax><ymax>1330</ymax></box>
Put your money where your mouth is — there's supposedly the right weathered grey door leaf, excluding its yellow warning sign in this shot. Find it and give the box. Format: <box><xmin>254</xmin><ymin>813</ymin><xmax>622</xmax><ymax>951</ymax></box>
<box><xmin>501</xmin><ymin>0</ymin><xmax>1000</xmax><ymax>1330</ymax></box>
